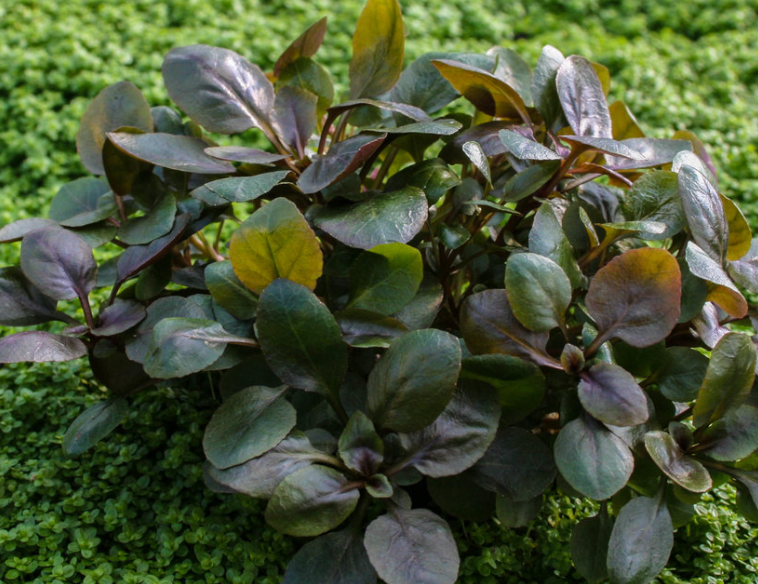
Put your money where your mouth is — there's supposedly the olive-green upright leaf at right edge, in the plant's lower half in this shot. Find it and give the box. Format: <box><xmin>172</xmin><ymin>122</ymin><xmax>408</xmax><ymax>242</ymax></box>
<box><xmin>692</xmin><ymin>333</ymin><xmax>756</xmax><ymax>428</ymax></box>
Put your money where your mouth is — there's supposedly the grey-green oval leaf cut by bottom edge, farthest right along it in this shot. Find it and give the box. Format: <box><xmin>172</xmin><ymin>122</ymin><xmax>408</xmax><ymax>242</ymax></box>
<box><xmin>607</xmin><ymin>497</ymin><xmax>674</xmax><ymax>584</ymax></box>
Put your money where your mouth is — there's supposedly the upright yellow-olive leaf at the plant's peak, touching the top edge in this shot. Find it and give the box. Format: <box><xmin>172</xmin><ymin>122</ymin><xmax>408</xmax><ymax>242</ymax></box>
<box><xmin>350</xmin><ymin>0</ymin><xmax>405</xmax><ymax>99</ymax></box>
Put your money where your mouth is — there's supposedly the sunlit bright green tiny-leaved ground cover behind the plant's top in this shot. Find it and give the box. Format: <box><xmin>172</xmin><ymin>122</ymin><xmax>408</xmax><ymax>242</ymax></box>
<box><xmin>0</xmin><ymin>0</ymin><xmax>758</xmax><ymax>232</ymax></box>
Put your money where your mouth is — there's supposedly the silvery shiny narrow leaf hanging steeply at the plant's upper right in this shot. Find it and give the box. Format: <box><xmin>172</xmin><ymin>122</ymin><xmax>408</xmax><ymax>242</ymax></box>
<box><xmin>679</xmin><ymin>166</ymin><xmax>729</xmax><ymax>265</ymax></box>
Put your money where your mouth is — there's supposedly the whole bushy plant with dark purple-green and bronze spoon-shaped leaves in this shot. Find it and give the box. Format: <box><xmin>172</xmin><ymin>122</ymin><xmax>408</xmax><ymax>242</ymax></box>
<box><xmin>0</xmin><ymin>0</ymin><xmax>758</xmax><ymax>584</ymax></box>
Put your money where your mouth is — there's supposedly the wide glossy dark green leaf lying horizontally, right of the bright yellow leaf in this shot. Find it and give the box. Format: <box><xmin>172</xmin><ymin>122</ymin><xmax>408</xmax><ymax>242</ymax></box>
<box><xmin>313</xmin><ymin>187</ymin><xmax>429</xmax><ymax>249</ymax></box>
